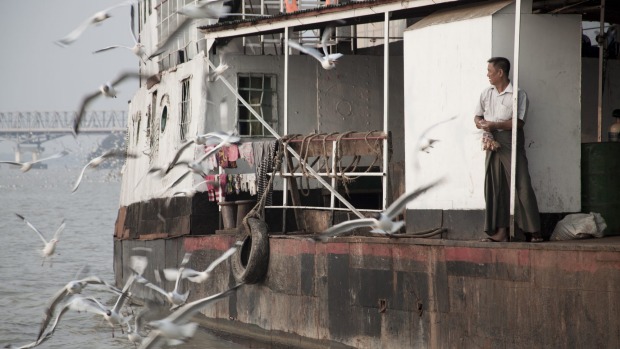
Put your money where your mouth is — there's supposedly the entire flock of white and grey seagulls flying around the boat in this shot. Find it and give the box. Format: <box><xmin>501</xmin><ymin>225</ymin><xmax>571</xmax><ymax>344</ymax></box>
<box><xmin>0</xmin><ymin>0</ymin><xmax>452</xmax><ymax>349</ymax></box>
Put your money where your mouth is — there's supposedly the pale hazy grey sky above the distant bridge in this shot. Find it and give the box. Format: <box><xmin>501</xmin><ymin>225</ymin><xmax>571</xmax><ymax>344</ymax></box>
<box><xmin>0</xmin><ymin>0</ymin><xmax>138</xmax><ymax>156</ymax></box>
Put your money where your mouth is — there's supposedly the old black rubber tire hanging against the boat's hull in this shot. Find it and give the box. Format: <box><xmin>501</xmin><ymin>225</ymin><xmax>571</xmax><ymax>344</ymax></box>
<box><xmin>231</xmin><ymin>218</ymin><xmax>269</xmax><ymax>284</ymax></box>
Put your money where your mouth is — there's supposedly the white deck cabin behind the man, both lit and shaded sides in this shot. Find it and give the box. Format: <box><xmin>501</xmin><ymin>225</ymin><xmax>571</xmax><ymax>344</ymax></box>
<box><xmin>404</xmin><ymin>9</ymin><xmax>581</xmax><ymax>212</ymax></box>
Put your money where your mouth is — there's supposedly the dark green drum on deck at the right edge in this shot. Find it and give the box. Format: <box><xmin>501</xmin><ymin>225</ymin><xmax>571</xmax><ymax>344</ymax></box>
<box><xmin>581</xmin><ymin>142</ymin><xmax>620</xmax><ymax>235</ymax></box>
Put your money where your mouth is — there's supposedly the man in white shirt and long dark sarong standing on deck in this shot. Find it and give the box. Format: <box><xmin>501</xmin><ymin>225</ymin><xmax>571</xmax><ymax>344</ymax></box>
<box><xmin>474</xmin><ymin>57</ymin><xmax>543</xmax><ymax>242</ymax></box>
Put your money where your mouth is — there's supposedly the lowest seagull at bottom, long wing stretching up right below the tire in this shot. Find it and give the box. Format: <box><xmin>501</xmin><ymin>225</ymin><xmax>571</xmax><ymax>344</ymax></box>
<box><xmin>139</xmin><ymin>283</ymin><xmax>243</xmax><ymax>349</ymax></box>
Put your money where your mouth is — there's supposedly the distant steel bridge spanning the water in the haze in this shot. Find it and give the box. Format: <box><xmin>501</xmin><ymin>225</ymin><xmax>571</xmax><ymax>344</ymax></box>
<box><xmin>0</xmin><ymin>111</ymin><xmax>127</xmax><ymax>162</ymax></box>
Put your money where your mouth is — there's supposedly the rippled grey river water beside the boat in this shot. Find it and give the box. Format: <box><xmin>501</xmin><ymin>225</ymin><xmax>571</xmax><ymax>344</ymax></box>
<box><xmin>0</xmin><ymin>164</ymin><xmax>254</xmax><ymax>349</ymax></box>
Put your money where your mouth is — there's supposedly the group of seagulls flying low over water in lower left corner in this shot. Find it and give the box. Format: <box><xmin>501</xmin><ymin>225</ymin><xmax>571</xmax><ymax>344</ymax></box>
<box><xmin>6</xmin><ymin>214</ymin><xmax>243</xmax><ymax>349</ymax></box>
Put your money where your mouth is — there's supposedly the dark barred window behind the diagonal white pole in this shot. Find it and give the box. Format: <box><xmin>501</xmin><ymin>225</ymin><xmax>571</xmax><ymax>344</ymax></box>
<box><xmin>237</xmin><ymin>74</ymin><xmax>278</xmax><ymax>137</ymax></box>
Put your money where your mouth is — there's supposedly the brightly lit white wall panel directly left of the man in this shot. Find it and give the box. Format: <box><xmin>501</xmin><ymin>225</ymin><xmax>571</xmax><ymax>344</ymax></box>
<box><xmin>404</xmin><ymin>17</ymin><xmax>492</xmax><ymax>210</ymax></box>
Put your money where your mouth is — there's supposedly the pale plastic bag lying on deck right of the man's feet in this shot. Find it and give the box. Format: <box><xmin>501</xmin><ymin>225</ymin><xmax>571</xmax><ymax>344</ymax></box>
<box><xmin>549</xmin><ymin>212</ymin><xmax>607</xmax><ymax>241</ymax></box>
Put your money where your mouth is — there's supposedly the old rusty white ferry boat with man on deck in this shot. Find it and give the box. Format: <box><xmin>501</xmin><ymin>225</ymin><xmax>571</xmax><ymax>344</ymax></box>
<box><xmin>114</xmin><ymin>0</ymin><xmax>620</xmax><ymax>348</ymax></box>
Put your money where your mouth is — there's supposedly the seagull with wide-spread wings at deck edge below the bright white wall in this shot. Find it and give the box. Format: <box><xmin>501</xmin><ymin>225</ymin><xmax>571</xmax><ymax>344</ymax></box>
<box><xmin>312</xmin><ymin>179</ymin><xmax>443</xmax><ymax>241</ymax></box>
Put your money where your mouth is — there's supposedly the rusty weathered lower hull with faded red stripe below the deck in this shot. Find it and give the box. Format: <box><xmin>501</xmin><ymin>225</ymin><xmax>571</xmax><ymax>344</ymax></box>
<box><xmin>115</xmin><ymin>235</ymin><xmax>620</xmax><ymax>348</ymax></box>
